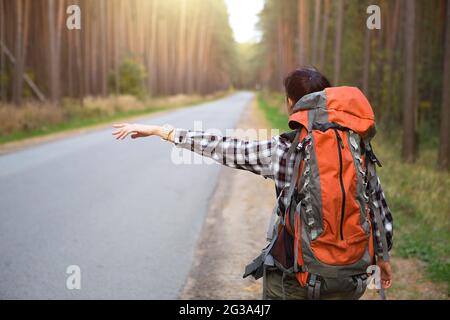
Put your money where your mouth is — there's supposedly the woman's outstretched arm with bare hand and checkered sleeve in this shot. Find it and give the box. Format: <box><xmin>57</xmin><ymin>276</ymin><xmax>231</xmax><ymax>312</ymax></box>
<box><xmin>113</xmin><ymin>123</ymin><xmax>276</xmax><ymax>178</ymax></box>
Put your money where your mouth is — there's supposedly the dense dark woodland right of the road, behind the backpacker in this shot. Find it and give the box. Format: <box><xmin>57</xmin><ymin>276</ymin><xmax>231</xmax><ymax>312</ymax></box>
<box><xmin>258</xmin><ymin>0</ymin><xmax>450</xmax><ymax>168</ymax></box>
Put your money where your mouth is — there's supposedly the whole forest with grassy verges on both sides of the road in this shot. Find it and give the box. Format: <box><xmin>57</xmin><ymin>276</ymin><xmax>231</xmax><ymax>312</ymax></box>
<box><xmin>0</xmin><ymin>0</ymin><xmax>450</xmax><ymax>298</ymax></box>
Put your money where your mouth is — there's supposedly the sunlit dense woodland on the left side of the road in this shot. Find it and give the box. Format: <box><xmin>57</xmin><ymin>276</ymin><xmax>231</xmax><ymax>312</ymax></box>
<box><xmin>0</xmin><ymin>0</ymin><xmax>234</xmax><ymax>101</ymax></box>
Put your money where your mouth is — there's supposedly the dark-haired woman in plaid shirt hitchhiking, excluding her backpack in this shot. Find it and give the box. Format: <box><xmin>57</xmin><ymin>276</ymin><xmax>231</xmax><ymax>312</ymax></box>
<box><xmin>113</xmin><ymin>67</ymin><xmax>392</xmax><ymax>299</ymax></box>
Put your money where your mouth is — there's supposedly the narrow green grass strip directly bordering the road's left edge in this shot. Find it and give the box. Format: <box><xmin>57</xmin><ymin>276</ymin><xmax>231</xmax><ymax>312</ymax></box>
<box><xmin>0</xmin><ymin>93</ymin><xmax>226</xmax><ymax>145</ymax></box>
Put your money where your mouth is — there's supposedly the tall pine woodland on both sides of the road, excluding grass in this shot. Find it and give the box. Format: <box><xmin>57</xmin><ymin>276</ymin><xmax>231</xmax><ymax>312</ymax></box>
<box><xmin>0</xmin><ymin>0</ymin><xmax>450</xmax><ymax>168</ymax></box>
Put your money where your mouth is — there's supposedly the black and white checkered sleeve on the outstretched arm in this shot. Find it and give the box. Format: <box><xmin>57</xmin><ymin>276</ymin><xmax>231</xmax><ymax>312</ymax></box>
<box><xmin>174</xmin><ymin>128</ymin><xmax>275</xmax><ymax>178</ymax></box>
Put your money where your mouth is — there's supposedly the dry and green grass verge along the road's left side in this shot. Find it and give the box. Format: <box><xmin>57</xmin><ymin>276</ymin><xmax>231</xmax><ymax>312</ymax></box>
<box><xmin>0</xmin><ymin>91</ymin><xmax>229</xmax><ymax>145</ymax></box>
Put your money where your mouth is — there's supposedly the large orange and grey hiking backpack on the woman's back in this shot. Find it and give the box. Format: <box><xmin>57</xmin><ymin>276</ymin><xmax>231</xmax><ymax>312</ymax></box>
<box><xmin>244</xmin><ymin>87</ymin><xmax>388</xmax><ymax>298</ymax></box>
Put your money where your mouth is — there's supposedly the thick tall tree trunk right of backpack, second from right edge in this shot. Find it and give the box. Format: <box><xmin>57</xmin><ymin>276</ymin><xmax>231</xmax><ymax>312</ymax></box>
<box><xmin>402</xmin><ymin>0</ymin><xmax>417</xmax><ymax>163</ymax></box>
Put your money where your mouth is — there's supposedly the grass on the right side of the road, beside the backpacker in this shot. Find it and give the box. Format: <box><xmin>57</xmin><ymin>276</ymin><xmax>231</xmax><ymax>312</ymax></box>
<box><xmin>257</xmin><ymin>92</ymin><xmax>450</xmax><ymax>288</ymax></box>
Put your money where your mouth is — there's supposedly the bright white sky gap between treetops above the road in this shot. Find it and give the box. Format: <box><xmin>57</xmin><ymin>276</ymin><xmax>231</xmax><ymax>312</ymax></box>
<box><xmin>225</xmin><ymin>0</ymin><xmax>264</xmax><ymax>42</ymax></box>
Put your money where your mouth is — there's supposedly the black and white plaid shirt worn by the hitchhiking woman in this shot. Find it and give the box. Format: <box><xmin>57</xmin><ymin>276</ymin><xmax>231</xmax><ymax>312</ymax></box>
<box><xmin>174</xmin><ymin>128</ymin><xmax>393</xmax><ymax>256</ymax></box>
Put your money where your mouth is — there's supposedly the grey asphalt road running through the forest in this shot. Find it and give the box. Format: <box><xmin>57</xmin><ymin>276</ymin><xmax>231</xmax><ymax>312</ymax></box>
<box><xmin>0</xmin><ymin>92</ymin><xmax>253</xmax><ymax>299</ymax></box>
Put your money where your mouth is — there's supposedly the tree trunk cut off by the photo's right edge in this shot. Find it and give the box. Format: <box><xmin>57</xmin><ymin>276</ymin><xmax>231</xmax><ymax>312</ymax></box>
<box><xmin>438</xmin><ymin>0</ymin><xmax>450</xmax><ymax>170</ymax></box>
